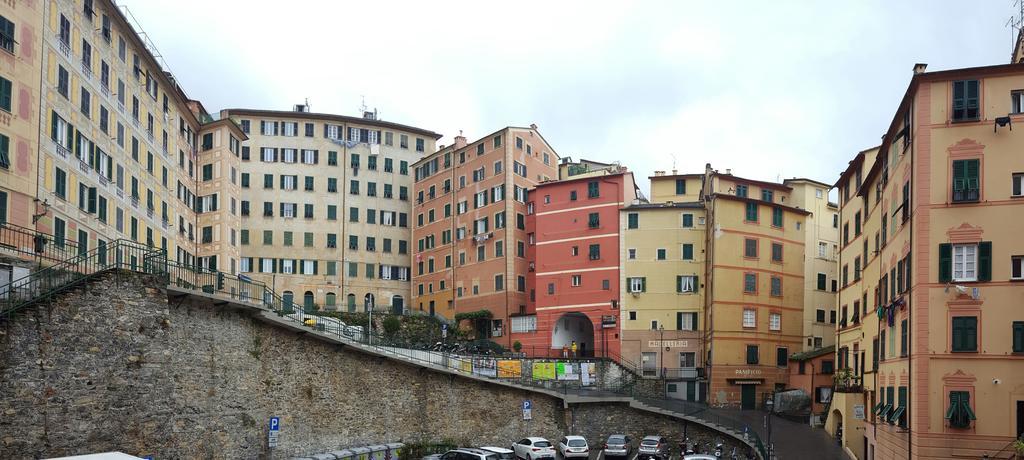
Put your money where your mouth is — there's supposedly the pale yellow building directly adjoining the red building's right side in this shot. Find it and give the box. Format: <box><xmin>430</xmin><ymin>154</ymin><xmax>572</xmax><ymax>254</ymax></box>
<box><xmin>620</xmin><ymin>171</ymin><xmax>707</xmax><ymax>401</ymax></box>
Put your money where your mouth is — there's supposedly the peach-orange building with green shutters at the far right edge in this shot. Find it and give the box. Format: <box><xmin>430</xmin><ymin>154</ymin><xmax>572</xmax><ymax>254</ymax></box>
<box><xmin>827</xmin><ymin>65</ymin><xmax>1024</xmax><ymax>459</ymax></box>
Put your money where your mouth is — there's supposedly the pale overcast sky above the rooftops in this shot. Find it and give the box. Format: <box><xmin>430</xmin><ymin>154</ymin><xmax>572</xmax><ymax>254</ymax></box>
<box><xmin>119</xmin><ymin>0</ymin><xmax>1014</xmax><ymax>189</ymax></box>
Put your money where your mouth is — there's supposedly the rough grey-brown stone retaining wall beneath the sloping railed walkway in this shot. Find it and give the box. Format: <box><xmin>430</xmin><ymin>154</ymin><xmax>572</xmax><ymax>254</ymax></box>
<box><xmin>0</xmin><ymin>271</ymin><xmax>731</xmax><ymax>459</ymax></box>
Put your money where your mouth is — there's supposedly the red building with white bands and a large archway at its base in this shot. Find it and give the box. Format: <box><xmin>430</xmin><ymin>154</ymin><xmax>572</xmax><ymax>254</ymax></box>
<box><xmin>511</xmin><ymin>167</ymin><xmax>637</xmax><ymax>357</ymax></box>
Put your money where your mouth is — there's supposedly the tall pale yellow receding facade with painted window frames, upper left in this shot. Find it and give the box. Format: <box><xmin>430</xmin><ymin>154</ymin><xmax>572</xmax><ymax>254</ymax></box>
<box><xmin>34</xmin><ymin>0</ymin><xmax>199</xmax><ymax>263</ymax></box>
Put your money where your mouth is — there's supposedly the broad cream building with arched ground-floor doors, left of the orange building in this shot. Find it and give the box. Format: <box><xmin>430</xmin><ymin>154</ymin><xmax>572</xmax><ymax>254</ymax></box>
<box><xmin>226</xmin><ymin>106</ymin><xmax>440</xmax><ymax>312</ymax></box>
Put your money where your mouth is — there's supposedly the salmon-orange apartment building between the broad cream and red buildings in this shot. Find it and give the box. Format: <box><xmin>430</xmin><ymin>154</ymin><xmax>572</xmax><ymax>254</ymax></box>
<box><xmin>413</xmin><ymin>125</ymin><xmax>558</xmax><ymax>347</ymax></box>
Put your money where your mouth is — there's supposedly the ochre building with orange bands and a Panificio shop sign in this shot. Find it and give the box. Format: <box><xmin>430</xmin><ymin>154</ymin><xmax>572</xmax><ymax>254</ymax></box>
<box><xmin>702</xmin><ymin>165</ymin><xmax>810</xmax><ymax>409</ymax></box>
